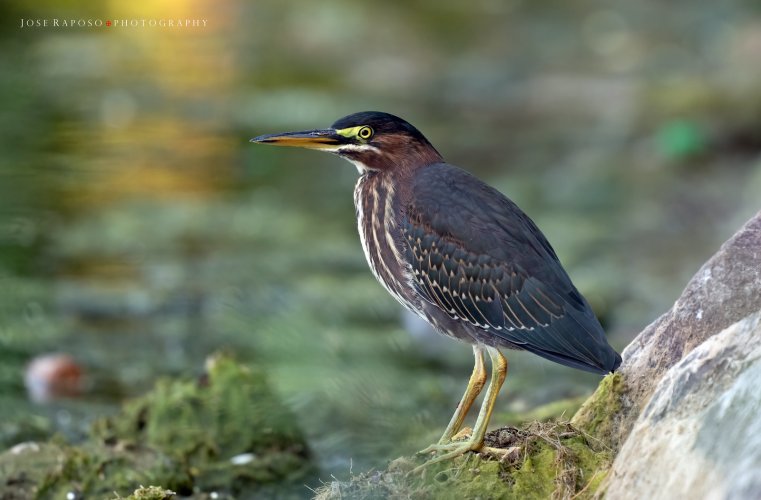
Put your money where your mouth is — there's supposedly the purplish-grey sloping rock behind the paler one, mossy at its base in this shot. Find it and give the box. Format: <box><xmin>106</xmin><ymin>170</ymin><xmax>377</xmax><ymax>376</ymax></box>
<box><xmin>573</xmin><ymin>212</ymin><xmax>761</xmax><ymax>448</ymax></box>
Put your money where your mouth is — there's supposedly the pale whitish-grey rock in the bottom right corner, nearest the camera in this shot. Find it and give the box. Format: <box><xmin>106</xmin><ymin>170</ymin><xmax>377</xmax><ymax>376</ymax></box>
<box><xmin>607</xmin><ymin>312</ymin><xmax>761</xmax><ymax>499</ymax></box>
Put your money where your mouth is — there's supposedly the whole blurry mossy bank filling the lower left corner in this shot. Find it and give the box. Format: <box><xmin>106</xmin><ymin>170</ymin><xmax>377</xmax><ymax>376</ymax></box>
<box><xmin>0</xmin><ymin>356</ymin><xmax>315</xmax><ymax>498</ymax></box>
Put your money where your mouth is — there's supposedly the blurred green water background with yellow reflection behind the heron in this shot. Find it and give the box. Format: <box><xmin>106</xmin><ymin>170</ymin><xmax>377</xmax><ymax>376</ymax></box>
<box><xmin>0</xmin><ymin>0</ymin><xmax>761</xmax><ymax>486</ymax></box>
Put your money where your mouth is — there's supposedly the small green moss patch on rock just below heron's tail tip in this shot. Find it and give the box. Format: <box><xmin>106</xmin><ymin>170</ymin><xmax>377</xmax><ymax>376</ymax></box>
<box><xmin>571</xmin><ymin>373</ymin><xmax>626</xmax><ymax>446</ymax></box>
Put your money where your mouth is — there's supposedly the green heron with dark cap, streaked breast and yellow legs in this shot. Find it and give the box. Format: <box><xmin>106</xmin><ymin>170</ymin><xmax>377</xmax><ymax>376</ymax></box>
<box><xmin>252</xmin><ymin>111</ymin><xmax>621</xmax><ymax>463</ymax></box>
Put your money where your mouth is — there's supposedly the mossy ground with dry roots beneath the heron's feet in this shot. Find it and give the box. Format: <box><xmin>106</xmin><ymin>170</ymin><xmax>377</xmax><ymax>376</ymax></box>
<box><xmin>316</xmin><ymin>421</ymin><xmax>612</xmax><ymax>500</ymax></box>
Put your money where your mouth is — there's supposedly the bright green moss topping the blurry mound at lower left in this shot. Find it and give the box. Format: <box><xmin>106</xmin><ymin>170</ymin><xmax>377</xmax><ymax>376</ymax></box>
<box><xmin>96</xmin><ymin>356</ymin><xmax>306</xmax><ymax>454</ymax></box>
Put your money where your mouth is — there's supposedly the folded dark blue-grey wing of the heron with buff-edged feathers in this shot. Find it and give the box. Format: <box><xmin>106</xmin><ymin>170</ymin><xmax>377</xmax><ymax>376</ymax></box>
<box><xmin>400</xmin><ymin>164</ymin><xmax>620</xmax><ymax>373</ymax></box>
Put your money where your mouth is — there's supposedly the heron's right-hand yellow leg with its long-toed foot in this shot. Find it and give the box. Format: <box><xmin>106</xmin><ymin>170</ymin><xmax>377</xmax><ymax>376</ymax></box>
<box><xmin>412</xmin><ymin>347</ymin><xmax>507</xmax><ymax>472</ymax></box>
